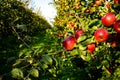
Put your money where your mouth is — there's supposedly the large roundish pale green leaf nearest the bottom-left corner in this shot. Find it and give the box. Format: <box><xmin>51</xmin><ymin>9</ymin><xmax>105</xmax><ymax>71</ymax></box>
<box><xmin>11</xmin><ymin>68</ymin><xmax>24</xmax><ymax>79</ymax></box>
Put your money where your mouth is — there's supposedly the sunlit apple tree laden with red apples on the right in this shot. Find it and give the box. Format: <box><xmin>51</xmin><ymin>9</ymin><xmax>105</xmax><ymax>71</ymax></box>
<box><xmin>54</xmin><ymin>0</ymin><xmax>120</xmax><ymax>80</ymax></box>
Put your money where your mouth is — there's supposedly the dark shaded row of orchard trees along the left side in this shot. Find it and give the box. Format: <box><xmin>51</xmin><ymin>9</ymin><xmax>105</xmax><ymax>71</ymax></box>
<box><xmin>0</xmin><ymin>0</ymin><xmax>51</xmax><ymax>80</ymax></box>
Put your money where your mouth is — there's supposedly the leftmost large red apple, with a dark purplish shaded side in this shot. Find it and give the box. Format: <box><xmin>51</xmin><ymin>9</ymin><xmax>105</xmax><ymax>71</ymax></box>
<box><xmin>63</xmin><ymin>36</ymin><xmax>76</xmax><ymax>50</ymax></box>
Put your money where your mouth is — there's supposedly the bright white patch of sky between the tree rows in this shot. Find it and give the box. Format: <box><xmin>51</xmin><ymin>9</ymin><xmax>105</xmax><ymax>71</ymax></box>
<box><xmin>30</xmin><ymin>0</ymin><xmax>56</xmax><ymax>25</ymax></box>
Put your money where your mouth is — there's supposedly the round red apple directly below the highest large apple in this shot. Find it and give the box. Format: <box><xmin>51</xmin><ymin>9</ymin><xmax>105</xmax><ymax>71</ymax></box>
<box><xmin>94</xmin><ymin>28</ymin><xmax>109</xmax><ymax>42</ymax></box>
